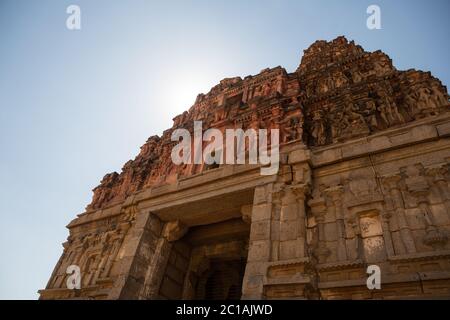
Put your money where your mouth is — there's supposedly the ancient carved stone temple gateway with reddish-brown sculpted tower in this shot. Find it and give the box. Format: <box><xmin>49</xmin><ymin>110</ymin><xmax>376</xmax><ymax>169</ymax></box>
<box><xmin>40</xmin><ymin>37</ymin><xmax>450</xmax><ymax>299</ymax></box>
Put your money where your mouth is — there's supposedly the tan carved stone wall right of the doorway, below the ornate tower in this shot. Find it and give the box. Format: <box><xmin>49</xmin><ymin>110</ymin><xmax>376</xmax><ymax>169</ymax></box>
<box><xmin>243</xmin><ymin>115</ymin><xmax>450</xmax><ymax>299</ymax></box>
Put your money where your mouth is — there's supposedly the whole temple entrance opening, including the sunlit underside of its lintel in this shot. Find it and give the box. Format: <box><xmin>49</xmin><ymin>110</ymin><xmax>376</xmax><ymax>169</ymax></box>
<box><xmin>152</xmin><ymin>188</ymin><xmax>254</xmax><ymax>300</ymax></box>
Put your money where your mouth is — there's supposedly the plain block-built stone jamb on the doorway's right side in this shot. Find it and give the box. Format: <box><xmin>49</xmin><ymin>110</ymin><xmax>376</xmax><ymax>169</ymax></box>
<box><xmin>242</xmin><ymin>183</ymin><xmax>274</xmax><ymax>299</ymax></box>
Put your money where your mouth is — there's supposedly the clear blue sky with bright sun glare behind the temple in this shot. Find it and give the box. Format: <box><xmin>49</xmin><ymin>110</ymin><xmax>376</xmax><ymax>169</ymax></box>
<box><xmin>0</xmin><ymin>0</ymin><xmax>450</xmax><ymax>299</ymax></box>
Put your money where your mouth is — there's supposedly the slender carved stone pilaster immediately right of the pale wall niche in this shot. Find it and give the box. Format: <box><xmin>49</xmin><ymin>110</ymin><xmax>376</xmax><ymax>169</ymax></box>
<box><xmin>383</xmin><ymin>174</ymin><xmax>416</xmax><ymax>253</ymax></box>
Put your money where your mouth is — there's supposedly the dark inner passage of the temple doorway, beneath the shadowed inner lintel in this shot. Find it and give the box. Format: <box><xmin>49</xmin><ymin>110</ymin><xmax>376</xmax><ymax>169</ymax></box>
<box><xmin>181</xmin><ymin>219</ymin><xmax>250</xmax><ymax>300</ymax></box>
